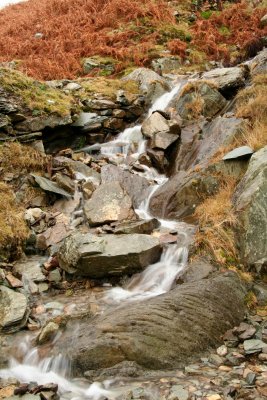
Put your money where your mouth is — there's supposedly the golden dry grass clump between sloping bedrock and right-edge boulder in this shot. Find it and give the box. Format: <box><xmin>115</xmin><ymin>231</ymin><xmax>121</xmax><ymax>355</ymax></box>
<box><xmin>194</xmin><ymin>177</ymin><xmax>238</xmax><ymax>264</ymax></box>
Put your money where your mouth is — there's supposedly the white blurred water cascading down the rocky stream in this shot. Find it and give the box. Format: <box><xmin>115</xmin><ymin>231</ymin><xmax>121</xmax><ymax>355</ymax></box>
<box><xmin>0</xmin><ymin>76</ymin><xmax>195</xmax><ymax>400</ymax></box>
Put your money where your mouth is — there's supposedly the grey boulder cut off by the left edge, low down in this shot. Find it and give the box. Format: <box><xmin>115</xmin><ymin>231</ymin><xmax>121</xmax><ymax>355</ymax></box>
<box><xmin>0</xmin><ymin>286</ymin><xmax>28</xmax><ymax>333</ymax></box>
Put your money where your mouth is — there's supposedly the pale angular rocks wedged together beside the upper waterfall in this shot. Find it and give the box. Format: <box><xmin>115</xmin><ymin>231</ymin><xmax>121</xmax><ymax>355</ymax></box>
<box><xmin>142</xmin><ymin>112</ymin><xmax>181</xmax><ymax>150</ymax></box>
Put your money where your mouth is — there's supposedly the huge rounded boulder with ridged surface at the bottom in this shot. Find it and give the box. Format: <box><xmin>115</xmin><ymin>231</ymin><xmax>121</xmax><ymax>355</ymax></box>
<box><xmin>59</xmin><ymin>273</ymin><xmax>245</xmax><ymax>374</ymax></box>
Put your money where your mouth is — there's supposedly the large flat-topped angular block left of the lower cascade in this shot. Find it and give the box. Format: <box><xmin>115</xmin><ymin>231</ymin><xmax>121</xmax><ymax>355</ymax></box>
<box><xmin>58</xmin><ymin>233</ymin><xmax>161</xmax><ymax>278</ymax></box>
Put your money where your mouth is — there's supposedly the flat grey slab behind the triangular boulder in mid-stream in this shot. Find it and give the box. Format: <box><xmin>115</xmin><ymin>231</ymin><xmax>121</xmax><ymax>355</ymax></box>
<box><xmin>101</xmin><ymin>164</ymin><xmax>150</xmax><ymax>208</ymax></box>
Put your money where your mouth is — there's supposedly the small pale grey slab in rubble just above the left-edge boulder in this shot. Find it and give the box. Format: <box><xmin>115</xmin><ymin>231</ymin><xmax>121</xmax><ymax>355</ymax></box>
<box><xmin>14</xmin><ymin>256</ymin><xmax>46</xmax><ymax>282</ymax></box>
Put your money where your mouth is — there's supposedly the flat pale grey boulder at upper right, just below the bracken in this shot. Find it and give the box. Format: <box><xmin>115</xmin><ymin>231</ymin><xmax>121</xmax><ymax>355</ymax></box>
<box><xmin>202</xmin><ymin>66</ymin><xmax>247</xmax><ymax>91</ymax></box>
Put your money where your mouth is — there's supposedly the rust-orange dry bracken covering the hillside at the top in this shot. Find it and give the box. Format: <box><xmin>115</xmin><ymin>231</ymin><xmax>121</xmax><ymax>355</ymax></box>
<box><xmin>0</xmin><ymin>0</ymin><xmax>267</xmax><ymax>79</ymax></box>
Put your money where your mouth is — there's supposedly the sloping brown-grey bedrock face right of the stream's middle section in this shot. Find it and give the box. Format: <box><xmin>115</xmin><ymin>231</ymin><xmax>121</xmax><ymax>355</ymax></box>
<box><xmin>150</xmin><ymin>117</ymin><xmax>247</xmax><ymax>219</ymax></box>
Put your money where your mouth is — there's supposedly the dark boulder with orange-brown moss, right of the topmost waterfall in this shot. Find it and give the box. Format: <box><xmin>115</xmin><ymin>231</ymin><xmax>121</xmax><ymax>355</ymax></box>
<box><xmin>172</xmin><ymin>81</ymin><xmax>227</xmax><ymax>120</ymax></box>
